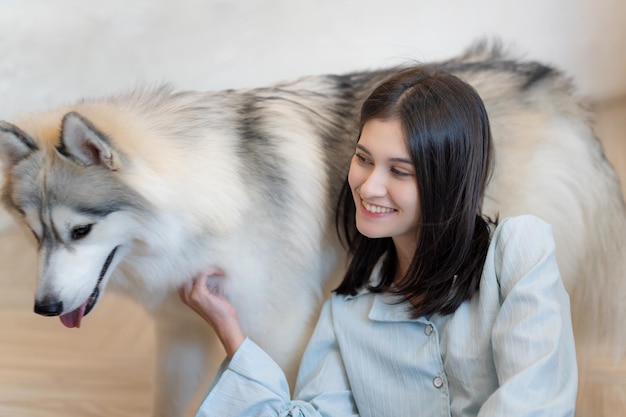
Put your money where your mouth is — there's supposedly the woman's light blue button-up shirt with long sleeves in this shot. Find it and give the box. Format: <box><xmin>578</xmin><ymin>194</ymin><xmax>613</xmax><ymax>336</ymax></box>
<box><xmin>197</xmin><ymin>216</ymin><xmax>578</xmax><ymax>417</ymax></box>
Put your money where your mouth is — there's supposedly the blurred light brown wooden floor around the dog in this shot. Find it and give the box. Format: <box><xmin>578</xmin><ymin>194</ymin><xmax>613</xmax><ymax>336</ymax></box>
<box><xmin>0</xmin><ymin>100</ymin><xmax>626</xmax><ymax>417</ymax></box>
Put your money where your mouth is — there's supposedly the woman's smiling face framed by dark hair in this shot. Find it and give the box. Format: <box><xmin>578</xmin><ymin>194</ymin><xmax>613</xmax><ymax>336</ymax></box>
<box><xmin>348</xmin><ymin>119</ymin><xmax>420</xmax><ymax>250</ymax></box>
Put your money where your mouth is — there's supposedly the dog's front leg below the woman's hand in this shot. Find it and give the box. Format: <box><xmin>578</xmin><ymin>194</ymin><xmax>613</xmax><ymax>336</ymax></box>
<box><xmin>152</xmin><ymin>313</ymin><xmax>226</xmax><ymax>417</ymax></box>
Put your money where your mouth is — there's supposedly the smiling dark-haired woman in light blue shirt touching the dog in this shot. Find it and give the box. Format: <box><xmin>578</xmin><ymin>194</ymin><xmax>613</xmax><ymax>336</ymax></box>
<box><xmin>181</xmin><ymin>66</ymin><xmax>578</xmax><ymax>417</ymax></box>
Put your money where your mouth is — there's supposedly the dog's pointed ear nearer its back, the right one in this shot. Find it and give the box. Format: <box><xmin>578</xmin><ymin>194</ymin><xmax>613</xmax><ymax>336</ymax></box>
<box><xmin>58</xmin><ymin>112</ymin><xmax>122</xmax><ymax>171</ymax></box>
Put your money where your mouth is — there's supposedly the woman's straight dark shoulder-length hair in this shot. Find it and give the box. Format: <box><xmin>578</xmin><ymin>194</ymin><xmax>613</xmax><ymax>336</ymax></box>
<box><xmin>335</xmin><ymin>66</ymin><xmax>492</xmax><ymax>317</ymax></box>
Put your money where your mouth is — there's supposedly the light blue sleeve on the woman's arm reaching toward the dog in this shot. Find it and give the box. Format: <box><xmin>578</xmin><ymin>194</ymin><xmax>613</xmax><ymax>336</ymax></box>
<box><xmin>196</xmin><ymin>303</ymin><xmax>358</xmax><ymax>417</ymax></box>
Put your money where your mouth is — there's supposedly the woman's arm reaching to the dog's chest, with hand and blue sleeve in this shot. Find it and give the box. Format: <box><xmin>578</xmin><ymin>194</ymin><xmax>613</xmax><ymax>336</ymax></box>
<box><xmin>180</xmin><ymin>274</ymin><xmax>358</xmax><ymax>417</ymax></box>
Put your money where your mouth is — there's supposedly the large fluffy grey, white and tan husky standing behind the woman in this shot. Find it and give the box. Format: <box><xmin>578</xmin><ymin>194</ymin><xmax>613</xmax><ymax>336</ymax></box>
<box><xmin>0</xmin><ymin>44</ymin><xmax>626</xmax><ymax>417</ymax></box>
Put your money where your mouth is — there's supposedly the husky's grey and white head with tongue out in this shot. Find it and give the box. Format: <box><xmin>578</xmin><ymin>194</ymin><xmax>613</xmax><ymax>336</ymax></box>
<box><xmin>0</xmin><ymin>112</ymin><xmax>146</xmax><ymax>327</ymax></box>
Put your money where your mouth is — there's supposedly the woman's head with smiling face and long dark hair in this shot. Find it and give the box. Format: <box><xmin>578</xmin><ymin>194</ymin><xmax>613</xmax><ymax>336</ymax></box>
<box><xmin>338</xmin><ymin>67</ymin><xmax>493</xmax><ymax>317</ymax></box>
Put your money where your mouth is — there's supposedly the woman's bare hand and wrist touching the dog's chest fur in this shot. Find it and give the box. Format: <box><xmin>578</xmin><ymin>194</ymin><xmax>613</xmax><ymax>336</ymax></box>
<box><xmin>178</xmin><ymin>269</ymin><xmax>245</xmax><ymax>358</ymax></box>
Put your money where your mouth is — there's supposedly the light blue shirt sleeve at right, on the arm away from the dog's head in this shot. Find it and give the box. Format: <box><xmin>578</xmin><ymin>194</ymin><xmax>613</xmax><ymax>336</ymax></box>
<box><xmin>478</xmin><ymin>216</ymin><xmax>578</xmax><ymax>417</ymax></box>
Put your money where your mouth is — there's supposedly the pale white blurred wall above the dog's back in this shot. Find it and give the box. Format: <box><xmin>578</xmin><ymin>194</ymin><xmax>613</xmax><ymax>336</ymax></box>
<box><xmin>0</xmin><ymin>0</ymin><xmax>626</xmax><ymax>228</ymax></box>
